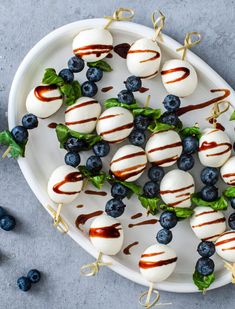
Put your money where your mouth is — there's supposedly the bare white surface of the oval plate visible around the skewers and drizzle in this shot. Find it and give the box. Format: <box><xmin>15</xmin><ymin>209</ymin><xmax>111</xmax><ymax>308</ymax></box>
<box><xmin>8</xmin><ymin>19</ymin><xmax>235</xmax><ymax>292</ymax></box>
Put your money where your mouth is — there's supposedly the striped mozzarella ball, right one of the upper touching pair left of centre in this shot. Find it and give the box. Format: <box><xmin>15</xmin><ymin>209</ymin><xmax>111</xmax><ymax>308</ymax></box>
<box><xmin>96</xmin><ymin>107</ymin><xmax>134</xmax><ymax>143</ymax></box>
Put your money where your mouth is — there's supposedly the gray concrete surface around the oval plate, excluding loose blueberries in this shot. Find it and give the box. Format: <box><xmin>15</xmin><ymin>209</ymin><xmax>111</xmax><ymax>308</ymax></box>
<box><xmin>0</xmin><ymin>0</ymin><xmax>235</xmax><ymax>309</ymax></box>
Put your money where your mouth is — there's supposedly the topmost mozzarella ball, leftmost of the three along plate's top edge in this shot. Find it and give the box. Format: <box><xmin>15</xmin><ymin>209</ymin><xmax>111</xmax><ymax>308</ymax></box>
<box><xmin>73</xmin><ymin>29</ymin><xmax>113</xmax><ymax>62</ymax></box>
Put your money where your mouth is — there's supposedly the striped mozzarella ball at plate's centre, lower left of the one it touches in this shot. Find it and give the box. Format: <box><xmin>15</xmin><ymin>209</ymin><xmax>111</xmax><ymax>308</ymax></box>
<box><xmin>110</xmin><ymin>145</ymin><xmax>147</xmax><ymax>181</ymax></box>
